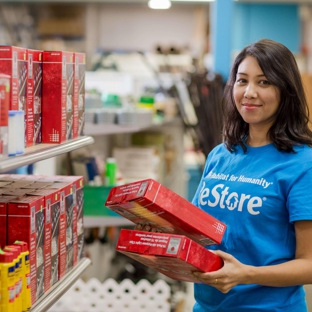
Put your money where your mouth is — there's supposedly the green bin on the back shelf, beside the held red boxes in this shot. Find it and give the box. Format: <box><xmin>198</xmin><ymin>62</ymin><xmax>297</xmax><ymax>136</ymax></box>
<box><xmin>83</xmin><ymin>185</ymin><xmax>122</xmax><ymax>218</ymax></box>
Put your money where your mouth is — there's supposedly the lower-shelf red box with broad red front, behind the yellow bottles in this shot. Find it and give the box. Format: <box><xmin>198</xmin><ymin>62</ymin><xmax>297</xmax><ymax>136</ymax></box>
<box><xmin>7</xmin><ymin>196</ymin><xmax>45</xmax><ymax>304</ymax></box>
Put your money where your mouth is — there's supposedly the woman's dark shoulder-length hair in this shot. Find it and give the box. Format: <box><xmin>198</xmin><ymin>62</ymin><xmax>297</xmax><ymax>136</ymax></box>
<box><xmin>222</xmin><ymin>39</ymin><xmax>312</xmax><ymax>152</ymax></box>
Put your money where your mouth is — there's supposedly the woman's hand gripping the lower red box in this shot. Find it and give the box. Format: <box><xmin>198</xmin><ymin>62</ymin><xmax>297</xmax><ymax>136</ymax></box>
<box><xmin>193</xmin><ymin>250</ymin><xmax>249</xmax><ymax>293</ymax></box>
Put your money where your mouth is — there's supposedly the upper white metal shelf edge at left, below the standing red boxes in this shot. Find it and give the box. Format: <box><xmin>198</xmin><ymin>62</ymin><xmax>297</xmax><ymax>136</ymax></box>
<box><xmin>0</xmin><ymin>136</ymin><xmax>94</xmax><ymax>172</ymax></box>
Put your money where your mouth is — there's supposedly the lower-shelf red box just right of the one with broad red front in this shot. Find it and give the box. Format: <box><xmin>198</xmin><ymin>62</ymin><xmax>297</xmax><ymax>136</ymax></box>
<box><xmin>29</xmin><ymin>189</ymin><xmax>60</xmax><ymax>292</ymax></box>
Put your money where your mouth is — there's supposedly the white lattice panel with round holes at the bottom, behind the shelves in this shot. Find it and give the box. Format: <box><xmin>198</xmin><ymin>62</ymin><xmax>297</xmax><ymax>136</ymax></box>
<box><xmin>49</xmin><ymin>278</ymin><xmax>170</xmax><ymax>312</ymax></box>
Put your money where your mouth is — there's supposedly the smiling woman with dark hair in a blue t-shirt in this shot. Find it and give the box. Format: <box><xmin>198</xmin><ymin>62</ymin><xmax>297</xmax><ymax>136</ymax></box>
<box><xmin>193</xmin><ymin>40</ymin><xmax>312</xmax><ymax>312</ymax></box>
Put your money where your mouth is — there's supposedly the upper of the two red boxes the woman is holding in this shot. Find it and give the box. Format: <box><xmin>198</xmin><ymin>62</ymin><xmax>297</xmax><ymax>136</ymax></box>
<box><xmin>105</xmin><ymin>179</ymin><xmax>226</xmax><ymax>246</ymax></box>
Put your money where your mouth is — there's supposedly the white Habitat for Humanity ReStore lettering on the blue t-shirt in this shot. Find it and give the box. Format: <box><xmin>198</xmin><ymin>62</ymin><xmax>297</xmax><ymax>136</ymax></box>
<box><xmin>199</xmin><ymin>172</ymin><xmax>273</xmax><ymax>215</ymax></box>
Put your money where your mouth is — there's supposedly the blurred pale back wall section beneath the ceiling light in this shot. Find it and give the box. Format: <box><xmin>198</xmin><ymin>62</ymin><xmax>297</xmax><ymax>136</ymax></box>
<box><xmin>86</xmin><ymin>4</ymin><xmax>209</xmax><ymax>67</ymax></box>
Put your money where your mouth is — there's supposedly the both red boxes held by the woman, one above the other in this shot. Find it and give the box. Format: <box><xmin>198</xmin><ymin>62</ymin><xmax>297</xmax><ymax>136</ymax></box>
<box><xmin>105</xmin><ymin>179</ymin><xmax>226</xmax><ymax>282</ymax></box>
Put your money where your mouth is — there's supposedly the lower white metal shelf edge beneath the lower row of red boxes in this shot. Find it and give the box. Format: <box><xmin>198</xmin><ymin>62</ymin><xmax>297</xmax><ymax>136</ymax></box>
<box><xmin>30</xmin><ymin>258</ymin><xmax>91</xmax><ymax>312</ymax></box>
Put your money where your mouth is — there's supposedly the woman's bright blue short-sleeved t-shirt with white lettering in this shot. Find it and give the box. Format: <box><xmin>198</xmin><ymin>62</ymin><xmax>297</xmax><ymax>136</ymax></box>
<box><xmin>192</xmin><ymin>144</ymin><xmax>312</xmax><ymax>312</ymax></box>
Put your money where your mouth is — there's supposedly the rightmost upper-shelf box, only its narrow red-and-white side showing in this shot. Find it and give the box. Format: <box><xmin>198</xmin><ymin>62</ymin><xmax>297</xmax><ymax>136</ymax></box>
<box><xmin>73</xmin><ymin>52</ymin><xmax>86</xmax><ymax>138</ymax></box>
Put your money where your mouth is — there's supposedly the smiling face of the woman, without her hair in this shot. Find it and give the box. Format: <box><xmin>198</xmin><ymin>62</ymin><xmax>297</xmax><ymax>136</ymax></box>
<box><xmin>233</xmin><ymin>56</ymin><xmax>280</xmax><ymax>131</ymax></box>
